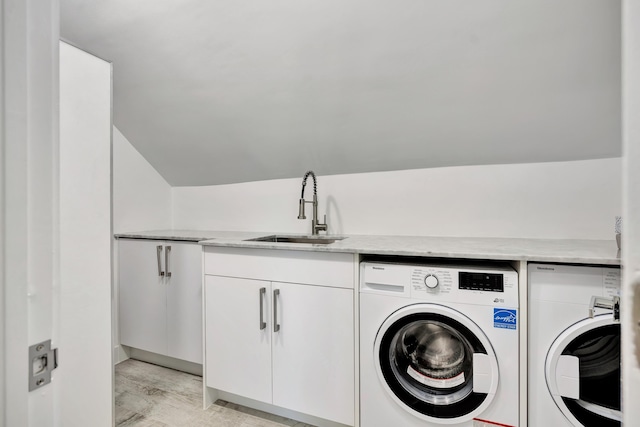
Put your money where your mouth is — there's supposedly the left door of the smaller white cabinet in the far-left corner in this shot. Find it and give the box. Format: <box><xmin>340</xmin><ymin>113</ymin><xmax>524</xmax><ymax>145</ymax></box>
<box><xmin>118</xmin><ymin>239</ymin><xmax>167</xmax><ymax>354</ymax></box>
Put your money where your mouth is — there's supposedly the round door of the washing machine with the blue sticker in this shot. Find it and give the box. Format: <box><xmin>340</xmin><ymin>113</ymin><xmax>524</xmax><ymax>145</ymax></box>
<box><xmin>374</xmin><ymin>304</ymin><xmax>499</xmax><ymax>424</ymax></box>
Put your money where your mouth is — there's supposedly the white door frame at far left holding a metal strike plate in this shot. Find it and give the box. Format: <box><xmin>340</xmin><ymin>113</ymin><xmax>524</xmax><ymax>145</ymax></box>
<box><xmin>0</xmin><ymin>0</ymin><xmax>60</xmax><ymax>426</ymax></box>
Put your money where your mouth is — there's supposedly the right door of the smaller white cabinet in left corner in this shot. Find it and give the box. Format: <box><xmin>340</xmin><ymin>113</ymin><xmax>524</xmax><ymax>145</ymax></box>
<box><xmin>164</xmin><ymin>242</ymin><xmax>202</xmax><ymax>363</ymax></box>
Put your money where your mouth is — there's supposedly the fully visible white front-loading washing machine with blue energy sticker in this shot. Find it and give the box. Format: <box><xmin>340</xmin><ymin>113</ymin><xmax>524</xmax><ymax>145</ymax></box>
<box><xmin>360</xmin><ymin>262</ymin><xmax>519</xmax><ymax>427</ymax></box>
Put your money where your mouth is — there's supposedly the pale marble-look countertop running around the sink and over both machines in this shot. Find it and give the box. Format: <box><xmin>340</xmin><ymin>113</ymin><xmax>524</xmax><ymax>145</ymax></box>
<box><xmin>116</xmin><ymin>230</ymin><xmax>620</xmax><ymax>265</ymax></box>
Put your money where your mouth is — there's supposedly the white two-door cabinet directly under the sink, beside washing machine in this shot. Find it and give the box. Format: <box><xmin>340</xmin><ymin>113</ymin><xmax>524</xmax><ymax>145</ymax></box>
<box><xmin>205</xmin><ymin>248</ymin><xmax>355</xmax><ymax>425</ymax></box>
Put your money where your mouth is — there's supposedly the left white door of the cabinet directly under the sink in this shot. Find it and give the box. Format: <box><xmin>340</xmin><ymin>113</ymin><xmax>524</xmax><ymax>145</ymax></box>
<box><xmin>205</xmin><ymin>276</ymin><xmax>272</xmax><ymax>403</ymax></box>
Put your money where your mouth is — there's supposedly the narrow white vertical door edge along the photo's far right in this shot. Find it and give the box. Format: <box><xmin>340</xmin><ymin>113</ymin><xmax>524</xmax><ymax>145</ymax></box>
<box><xmin>621</xmin><ymin>0</ymin><xmax>640</xmax><ymax>426</ymax></box>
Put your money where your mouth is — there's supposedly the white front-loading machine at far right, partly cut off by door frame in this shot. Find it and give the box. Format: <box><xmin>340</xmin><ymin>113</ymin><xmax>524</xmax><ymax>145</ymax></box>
<box><xmin>528</xmin><ymin>264</ymin><xmax>622</xmax><ymax>427</ymax></box>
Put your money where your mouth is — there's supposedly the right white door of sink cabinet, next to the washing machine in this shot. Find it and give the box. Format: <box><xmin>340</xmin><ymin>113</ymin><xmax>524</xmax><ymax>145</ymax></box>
<box><xmin>272</xmin><ymin>282</ymin><xmax>355</xmax><ymax>425</ymax></box>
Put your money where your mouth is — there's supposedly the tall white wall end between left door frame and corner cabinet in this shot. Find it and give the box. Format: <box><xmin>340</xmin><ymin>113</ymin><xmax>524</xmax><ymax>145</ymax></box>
<box><xmin>59</xmin><ymin>43</ymin><xmax>113</xmax><ymax>427</ymax></box>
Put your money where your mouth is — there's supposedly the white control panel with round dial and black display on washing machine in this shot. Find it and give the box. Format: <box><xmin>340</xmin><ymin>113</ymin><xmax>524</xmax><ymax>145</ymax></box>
<box><xmin>360</xmin><ymin>262</ymin><xmax>518</xmax><ymax>307</ymax></box>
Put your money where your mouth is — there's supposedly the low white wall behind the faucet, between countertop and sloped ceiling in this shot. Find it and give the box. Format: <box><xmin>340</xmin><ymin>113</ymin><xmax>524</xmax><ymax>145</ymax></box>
<box><xmin>172</xmin><ymin>158</ymin><xmax>622</xmax><ymax>239</ymax></box>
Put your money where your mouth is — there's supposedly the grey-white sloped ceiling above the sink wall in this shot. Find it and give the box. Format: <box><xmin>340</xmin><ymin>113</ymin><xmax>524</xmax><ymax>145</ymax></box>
<box><xmin>61</xmin><ymin>0</ymin><xmax>621</xmax><ymax>186</ymax></box>
